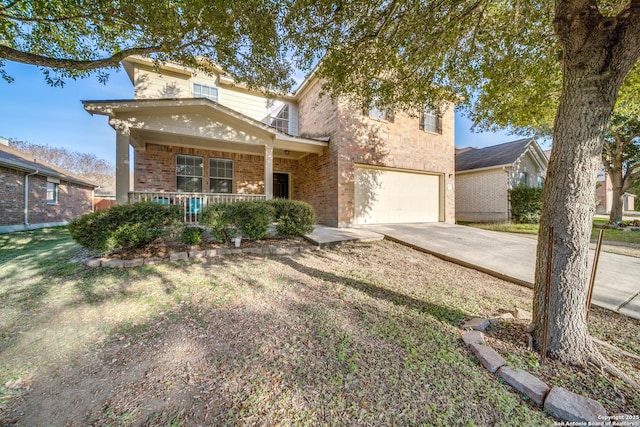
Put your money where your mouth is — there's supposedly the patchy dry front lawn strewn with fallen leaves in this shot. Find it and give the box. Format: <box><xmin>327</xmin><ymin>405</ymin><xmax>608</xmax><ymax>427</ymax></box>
<box><xmin>0</xmin><ymin>228</ymin><xmax>640</xmax><ymax>426</ymax></box>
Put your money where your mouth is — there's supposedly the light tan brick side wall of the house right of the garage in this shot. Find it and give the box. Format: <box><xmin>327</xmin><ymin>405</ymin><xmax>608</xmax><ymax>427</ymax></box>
<box><xmin>456</xmin><ymin>168</ymin><xmax>509</xmax><ymax>222</ymax></box>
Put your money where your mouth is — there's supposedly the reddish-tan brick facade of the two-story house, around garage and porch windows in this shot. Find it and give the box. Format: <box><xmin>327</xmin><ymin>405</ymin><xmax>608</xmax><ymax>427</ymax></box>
<box><xmin>129</xmin><ymin>81</ymin><xmax>455</xmax><ymax>227</ymax></box>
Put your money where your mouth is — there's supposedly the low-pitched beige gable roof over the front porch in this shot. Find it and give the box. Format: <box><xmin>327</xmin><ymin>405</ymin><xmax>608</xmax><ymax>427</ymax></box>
<box><xmin>83</xmin><ymin>98</ymin><xmax>328</xmax><ymax>158</ymax></box>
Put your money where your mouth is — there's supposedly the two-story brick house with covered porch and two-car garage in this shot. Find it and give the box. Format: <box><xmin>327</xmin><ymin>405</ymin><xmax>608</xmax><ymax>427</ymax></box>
<box><xmin>83</xmin><ymin>57</ymin><xmax>455</xmax><ymax>227</ymax></box>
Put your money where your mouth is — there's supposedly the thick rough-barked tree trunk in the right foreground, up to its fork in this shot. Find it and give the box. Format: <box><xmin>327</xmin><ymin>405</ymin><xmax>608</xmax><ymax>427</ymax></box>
<box><xmin>533</xmin><ymin>0</ymin><xmax>640</xmax><ymax>365</ymax></box>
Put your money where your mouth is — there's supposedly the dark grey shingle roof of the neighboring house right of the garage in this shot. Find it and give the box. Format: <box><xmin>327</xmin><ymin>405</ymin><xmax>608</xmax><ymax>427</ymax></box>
<box><xmin>456</xmin><ymin>138</ymin><xmax>533</xmax><ymax>172</ymax></box>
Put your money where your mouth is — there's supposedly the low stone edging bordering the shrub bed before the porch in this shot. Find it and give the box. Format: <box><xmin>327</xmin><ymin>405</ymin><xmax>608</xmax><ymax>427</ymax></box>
<box><xmin>84</xmin><ymin>246</ymin><xmax>320</xmax><ymax>268</ymax></box>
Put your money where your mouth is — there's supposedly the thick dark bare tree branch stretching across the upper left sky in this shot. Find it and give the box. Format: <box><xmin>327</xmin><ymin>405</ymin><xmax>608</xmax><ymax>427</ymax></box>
<box><xmin>0</xmin><ymin>44</ymin><xmax>161</xmax><ymax>71</ymax></box>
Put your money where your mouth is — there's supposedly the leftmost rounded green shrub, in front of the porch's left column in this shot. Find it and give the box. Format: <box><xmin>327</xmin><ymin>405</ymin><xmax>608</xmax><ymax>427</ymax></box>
<box><xmin>69</xmin><ymin>202</ymin><xmax>182</xmax><ymax>253</ymax></box>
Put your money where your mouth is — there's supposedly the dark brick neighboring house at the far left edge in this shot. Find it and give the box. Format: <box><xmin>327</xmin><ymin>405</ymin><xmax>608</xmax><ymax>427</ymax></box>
<box><xmin>0</xmin><ymin>138</ymin><xmax>97</xmax><ymax>233</ymax></box>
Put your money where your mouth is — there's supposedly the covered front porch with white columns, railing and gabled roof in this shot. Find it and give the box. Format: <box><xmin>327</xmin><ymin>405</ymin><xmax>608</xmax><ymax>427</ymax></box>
<box><xmin>84</xmin><ymin>98</ymin><xmax>328</xmax><ymax>222</ymax></box>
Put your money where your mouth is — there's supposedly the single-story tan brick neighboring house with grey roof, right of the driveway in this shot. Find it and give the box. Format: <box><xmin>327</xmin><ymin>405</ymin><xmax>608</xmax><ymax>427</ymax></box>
<box><xmin>456</xmin><ymin>138</ymin><xmax>548</xmax><ymax>222</ymax></box>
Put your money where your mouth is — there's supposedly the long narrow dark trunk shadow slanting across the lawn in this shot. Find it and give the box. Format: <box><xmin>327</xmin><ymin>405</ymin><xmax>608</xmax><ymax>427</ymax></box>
<box><xmin>278</xmin><ymin>257</ymin><xmax>468</xmax><ymax>327</ymax></box>
